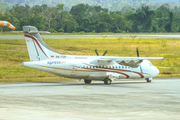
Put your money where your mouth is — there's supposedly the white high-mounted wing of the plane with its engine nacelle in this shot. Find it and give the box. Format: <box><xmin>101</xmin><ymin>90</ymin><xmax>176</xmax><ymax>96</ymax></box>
<box><xmin>90</xmin><ymin>57</ymin><xmax>164</xmax><ymax>68</ymax></box>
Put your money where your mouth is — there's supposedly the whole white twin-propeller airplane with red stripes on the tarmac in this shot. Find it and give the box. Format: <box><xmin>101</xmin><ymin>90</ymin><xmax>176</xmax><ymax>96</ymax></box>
<box><xmin>22</xmin><ymin>26</ymin><xmax>163</xmax><ymax>85</ymax></box>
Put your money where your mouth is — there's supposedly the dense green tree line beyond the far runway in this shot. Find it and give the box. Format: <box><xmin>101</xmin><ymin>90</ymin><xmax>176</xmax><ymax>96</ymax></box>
<box><xmin>0</xmin><ymin>4</ymin><xmax>180</xmax><ymax>33</ymax></box>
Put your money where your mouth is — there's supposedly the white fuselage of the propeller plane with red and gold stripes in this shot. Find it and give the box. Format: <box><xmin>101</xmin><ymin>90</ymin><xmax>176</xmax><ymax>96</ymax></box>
<box><xmin>22</xmin><ymin>56</ymin><xmax>159</xmax><ymax>81</ymax></box>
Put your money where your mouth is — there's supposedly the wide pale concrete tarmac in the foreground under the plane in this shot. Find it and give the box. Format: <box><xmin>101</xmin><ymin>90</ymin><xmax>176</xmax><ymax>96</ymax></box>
<box><xmin>0</xmin><ymin>78</ymin><xmax>180</xmax><ymax>120</ymax></box>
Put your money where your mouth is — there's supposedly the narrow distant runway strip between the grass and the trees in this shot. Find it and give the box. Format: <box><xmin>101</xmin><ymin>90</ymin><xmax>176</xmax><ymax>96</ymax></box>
<box><xmin>0</xmin><ymin>34</ymin><xmax>180</xmax><ymax>39</ymax></box>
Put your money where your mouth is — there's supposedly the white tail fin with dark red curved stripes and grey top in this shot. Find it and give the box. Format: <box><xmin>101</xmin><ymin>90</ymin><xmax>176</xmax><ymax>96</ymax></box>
<box><xmin>23</xmin><ymin>26</ymin><xmax>60</xmax><ymax>61</ymax></box>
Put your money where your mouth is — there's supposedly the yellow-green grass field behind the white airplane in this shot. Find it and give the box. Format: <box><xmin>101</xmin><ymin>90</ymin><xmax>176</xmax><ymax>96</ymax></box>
<box><xmin>0</xmin><ymin>38</ymin><xmax>180</xmax><ymax>82</ymax></box>
